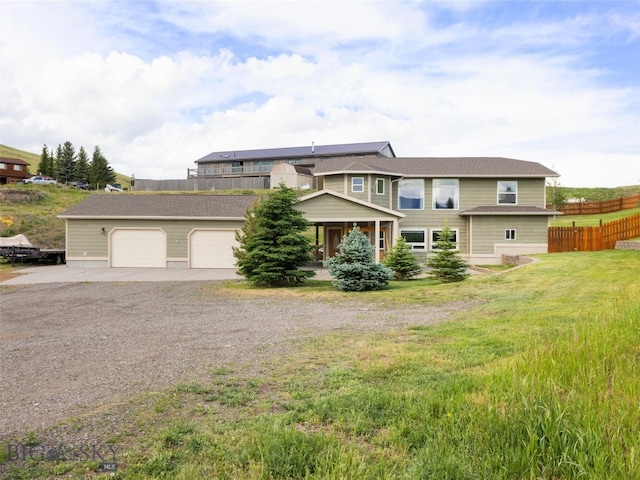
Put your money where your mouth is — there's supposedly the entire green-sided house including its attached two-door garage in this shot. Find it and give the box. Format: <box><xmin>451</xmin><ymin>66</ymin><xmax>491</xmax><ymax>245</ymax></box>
<box><xmin>60</xmin><ymin>156</ymin><xmax>560</xmax><ymax>268</ymax></box>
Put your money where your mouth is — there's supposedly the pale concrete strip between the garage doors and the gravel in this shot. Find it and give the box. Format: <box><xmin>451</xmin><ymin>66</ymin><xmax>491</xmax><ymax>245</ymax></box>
<box><xmin>0</xmin><ymin>265</ymin><xmax>331</xmax><ymax>285</ymax></box>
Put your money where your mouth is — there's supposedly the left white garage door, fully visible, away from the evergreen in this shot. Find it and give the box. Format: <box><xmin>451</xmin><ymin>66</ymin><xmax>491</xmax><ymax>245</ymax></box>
<box><xmin>110</xmin><ymin>229</ymin><xmax>167</xmax><ymax>268</ymax></box>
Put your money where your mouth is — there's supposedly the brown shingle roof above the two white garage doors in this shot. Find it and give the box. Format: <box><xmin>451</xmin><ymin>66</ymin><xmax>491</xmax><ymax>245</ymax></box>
<box><xmin>59</xmin><ymin>193</ymin><xmax>258</xmax><ymax>219</ymax></box>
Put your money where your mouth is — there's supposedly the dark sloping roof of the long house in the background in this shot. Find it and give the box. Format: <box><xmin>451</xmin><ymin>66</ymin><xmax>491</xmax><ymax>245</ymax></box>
<box><xmin>195</xmin><ymin>142</ymin><xmax>395</xmax><ymax>163</ymax></box>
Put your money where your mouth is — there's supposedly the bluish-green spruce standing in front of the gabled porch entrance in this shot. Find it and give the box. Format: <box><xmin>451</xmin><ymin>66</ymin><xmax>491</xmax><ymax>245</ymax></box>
<box><xmin>327</xmin><ymin>224</ymin><xmax>393</xmax><ymax>292</ymax></box>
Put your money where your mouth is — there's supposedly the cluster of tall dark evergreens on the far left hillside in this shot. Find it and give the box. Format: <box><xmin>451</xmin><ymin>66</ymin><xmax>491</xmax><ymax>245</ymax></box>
<box><xmin>38</xmin><ymin>141</ymin><xmax>116</xmax><ymax>188</ymax></box>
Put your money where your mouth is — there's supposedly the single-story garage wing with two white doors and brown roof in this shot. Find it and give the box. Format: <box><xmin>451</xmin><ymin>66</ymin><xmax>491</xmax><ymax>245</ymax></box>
<box><xmin>59</xmin><ymin>193</ymin><xmax>256</xmax><ymax>268</ymax></box>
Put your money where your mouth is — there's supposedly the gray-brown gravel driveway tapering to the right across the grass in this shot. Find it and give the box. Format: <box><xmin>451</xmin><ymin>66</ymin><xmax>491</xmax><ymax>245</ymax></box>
<box><xmin>0</xmin><ymin>281</ymin><xmax>468</xmax><ymax>440</ymax></box>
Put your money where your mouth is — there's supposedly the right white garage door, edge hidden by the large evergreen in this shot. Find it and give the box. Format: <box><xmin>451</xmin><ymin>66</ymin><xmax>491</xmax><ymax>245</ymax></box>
<box><xmin>189</xmin><ymin>230</ymin><xmax>238</xmax><ymax>268</ymax></box>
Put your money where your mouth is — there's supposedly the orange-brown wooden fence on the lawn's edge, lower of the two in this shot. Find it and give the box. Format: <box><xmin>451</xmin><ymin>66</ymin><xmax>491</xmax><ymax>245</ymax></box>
<box><xmin>548</xmin><ymin>214</ymin><xmax>640</xmax><ymax>253</ymax></box>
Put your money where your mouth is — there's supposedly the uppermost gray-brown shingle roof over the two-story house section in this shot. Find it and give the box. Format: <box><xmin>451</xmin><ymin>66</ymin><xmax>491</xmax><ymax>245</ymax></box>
<box><xmin>315</xmin><ymin>157</ymin><xmax>558</xmax><ymax>178</ymax></box>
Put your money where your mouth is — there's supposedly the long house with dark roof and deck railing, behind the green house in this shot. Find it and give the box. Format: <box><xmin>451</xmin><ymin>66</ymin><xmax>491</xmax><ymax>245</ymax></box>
<box><xmin>188</xmin><ymin>142</ymin><xmax>395</xmax><ymax>182</ymax></box>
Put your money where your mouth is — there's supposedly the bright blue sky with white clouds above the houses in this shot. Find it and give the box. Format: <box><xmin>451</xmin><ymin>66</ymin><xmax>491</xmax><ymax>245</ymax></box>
<box><xmin>0</xmin><ymin>0</ymin><xmax>640</xmax><ymax>187</ymax></box>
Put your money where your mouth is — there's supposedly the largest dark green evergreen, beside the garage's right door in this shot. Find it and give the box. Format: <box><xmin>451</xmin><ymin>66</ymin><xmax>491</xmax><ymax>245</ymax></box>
<box><xmin>233</xmin><ymin>183</ymin><xmax>315</xmax><ymax>287</ymax></box>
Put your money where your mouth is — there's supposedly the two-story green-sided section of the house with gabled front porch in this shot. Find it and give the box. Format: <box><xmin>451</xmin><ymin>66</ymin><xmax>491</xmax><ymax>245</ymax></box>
<box><xmin>297</xmin><ymin>157</ymin><xmax>559</xmax><ymax>264</ymax></box>
